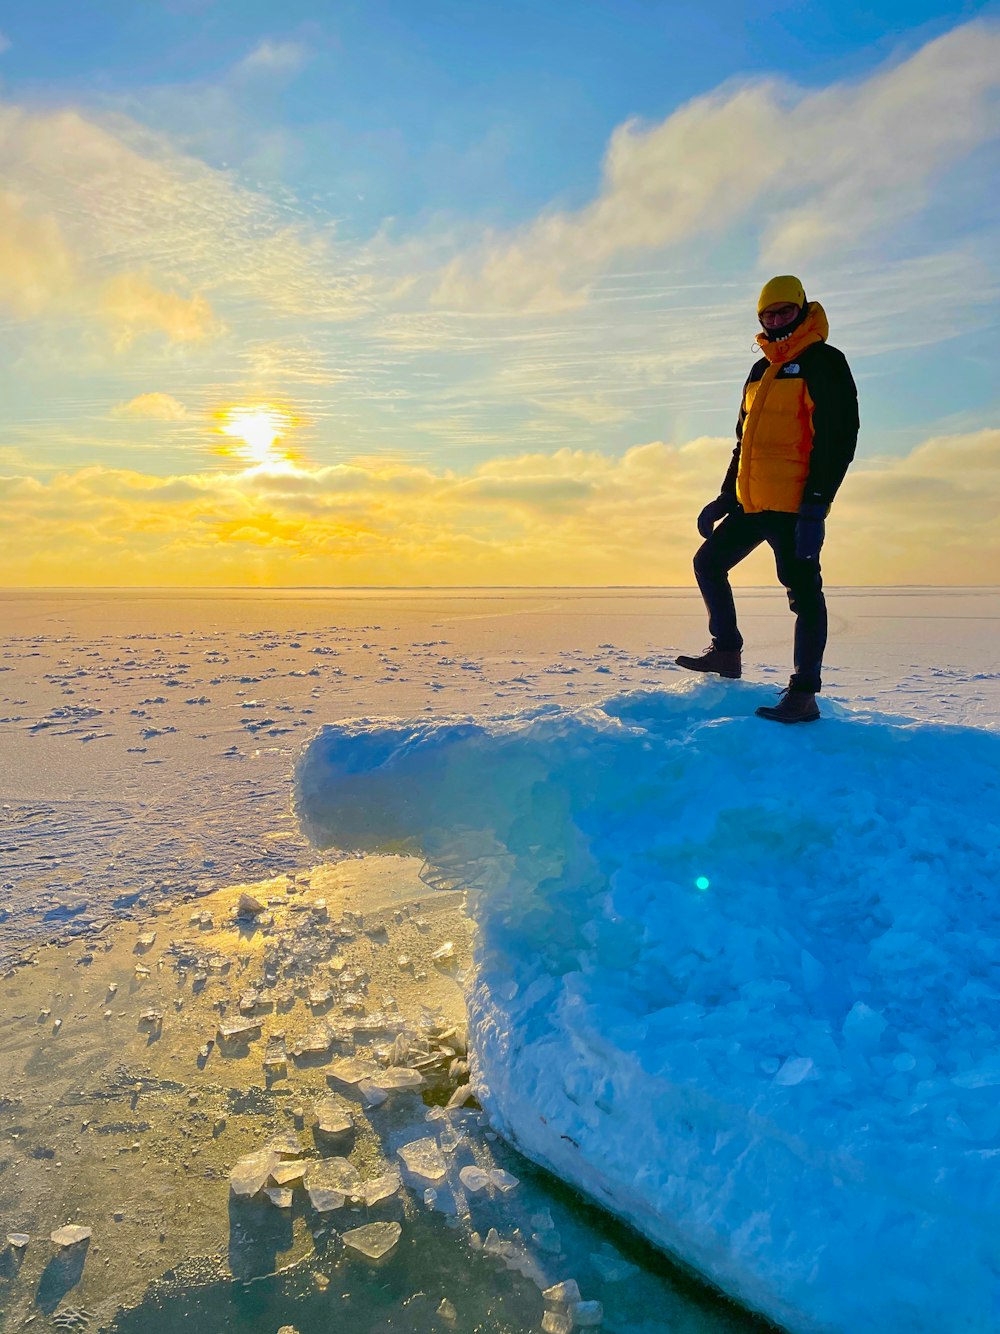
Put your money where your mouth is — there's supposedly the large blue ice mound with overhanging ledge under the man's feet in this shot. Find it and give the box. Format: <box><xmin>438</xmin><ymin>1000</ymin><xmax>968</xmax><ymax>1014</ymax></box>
<box><xmin>296</xmin><ymin>680</ymin><xmax>1000</xmax><ymax>1334</ymax></box>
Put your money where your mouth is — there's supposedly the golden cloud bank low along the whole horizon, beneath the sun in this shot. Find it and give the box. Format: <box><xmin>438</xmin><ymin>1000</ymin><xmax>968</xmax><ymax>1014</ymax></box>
<box><xmin>0</xmin><ymin>430</ymin><xmax>1000</xmax><ymax>586</ymax></box>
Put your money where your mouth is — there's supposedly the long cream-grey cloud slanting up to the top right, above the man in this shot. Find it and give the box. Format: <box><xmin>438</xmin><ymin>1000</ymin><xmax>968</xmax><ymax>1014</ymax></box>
<box><xmin>435</xmin><ymin>21</ymin><xmax>1000</xmax><ymax>311</ymax></box>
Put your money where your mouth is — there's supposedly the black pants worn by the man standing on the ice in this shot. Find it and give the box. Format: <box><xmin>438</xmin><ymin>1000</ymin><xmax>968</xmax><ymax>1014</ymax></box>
<box><xmin>695</xmin><ymin>510</ymin><xmax>827</xmax><ymax>691</ymax></box>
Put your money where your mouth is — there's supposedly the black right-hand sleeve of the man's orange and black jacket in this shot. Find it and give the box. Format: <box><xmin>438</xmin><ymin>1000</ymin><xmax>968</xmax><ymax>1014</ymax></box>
<box><xmin>801</xmin><ymin>343</ymin><xmax>860</xmax><ymax>506</ymax></box>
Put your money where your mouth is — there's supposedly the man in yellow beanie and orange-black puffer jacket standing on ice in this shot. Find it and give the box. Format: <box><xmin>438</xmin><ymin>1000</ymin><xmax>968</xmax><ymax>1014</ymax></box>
<box><xmin>677</xmin><ymin>275</ymin><xmax>859</xmax><ymax>723</ymax></box>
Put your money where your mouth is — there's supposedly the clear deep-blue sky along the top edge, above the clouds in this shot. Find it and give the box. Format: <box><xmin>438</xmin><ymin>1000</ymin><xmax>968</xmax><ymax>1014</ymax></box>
<box><xmin>3</xmin><ymin>0</ymin><xmax>1000</xmax><ymax>236</ymax></box>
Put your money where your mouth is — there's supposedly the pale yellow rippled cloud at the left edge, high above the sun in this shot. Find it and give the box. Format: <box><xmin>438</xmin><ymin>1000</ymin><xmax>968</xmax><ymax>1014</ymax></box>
<box><xmin>0</xmin><ymin>104</ymin><xmax>372</xmax><ymax>343</ymax></box>
